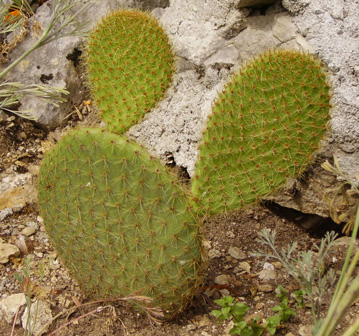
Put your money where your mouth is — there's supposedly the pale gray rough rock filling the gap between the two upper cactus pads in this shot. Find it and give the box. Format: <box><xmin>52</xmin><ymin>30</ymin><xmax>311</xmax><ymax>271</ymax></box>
<box><xmin>127</xmin><ymin>5</ymin><xmax>309</xmax><ymax>175</ymax></box>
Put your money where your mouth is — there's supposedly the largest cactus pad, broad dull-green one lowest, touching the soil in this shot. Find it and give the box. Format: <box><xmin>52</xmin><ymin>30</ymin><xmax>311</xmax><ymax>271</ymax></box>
<box><xmin>39</xmin><ymin>129</ymin><xmax>201</xmax><ymax>316</ymax></box>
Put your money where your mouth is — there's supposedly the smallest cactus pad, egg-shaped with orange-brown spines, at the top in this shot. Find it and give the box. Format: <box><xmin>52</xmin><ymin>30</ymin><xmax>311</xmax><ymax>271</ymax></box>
<box><xmin>86</xmin><ymin>10</ymin><xmax>174</xmax><ymax>133</ymax></box>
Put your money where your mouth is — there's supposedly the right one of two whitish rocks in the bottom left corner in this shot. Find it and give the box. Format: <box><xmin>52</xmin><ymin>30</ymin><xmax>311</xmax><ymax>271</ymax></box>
<box><xmin>21</xmin><ymin>301</ymin><xmax>53</xmax><ymax>335</ymax></box>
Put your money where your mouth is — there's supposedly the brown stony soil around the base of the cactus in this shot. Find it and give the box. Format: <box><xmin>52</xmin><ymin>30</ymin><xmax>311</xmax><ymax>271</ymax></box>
<box><xmin>0</xmin><ymin>112</ymin><xmax>359</xmax><ymax>336</ymax></box>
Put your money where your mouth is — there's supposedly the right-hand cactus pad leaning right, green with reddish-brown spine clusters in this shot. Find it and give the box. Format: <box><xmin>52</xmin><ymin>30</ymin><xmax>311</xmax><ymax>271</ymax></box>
<box><xmin>192</xmin><ymin>51</ymin><xmax>331</xmax><ymax>214</ymax></box>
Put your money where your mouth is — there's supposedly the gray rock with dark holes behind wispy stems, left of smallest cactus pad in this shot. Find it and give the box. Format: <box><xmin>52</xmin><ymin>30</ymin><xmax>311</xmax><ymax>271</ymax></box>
<box><xmin>5</xmin><ymin>0</ymin><xmax>133</xmax><ymax>127</ymax></box>
